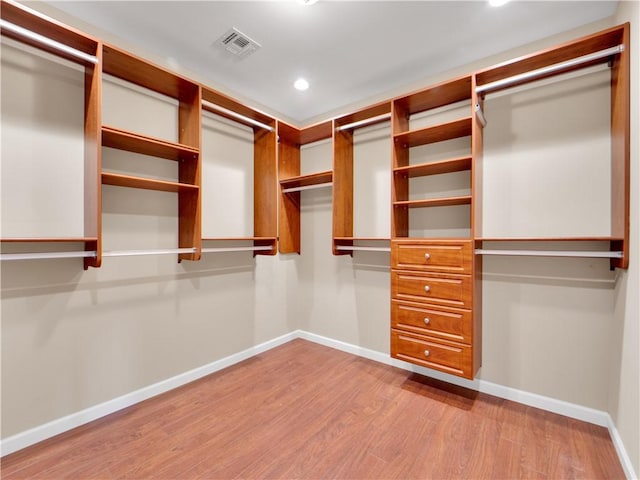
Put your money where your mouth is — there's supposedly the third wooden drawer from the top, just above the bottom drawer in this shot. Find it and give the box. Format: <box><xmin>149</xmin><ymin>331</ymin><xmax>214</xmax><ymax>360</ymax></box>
<box><xmin>391</xmin><ymin>300</ymin><xmax>473</xmax><ymax>344</ymax></box>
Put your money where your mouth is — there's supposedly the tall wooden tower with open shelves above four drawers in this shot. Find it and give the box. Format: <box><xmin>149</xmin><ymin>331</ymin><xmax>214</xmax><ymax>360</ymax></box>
<box><xmin>391</xmin><ymin>76</ymin><xmax>482</xmax><ymax>378</ymax></box>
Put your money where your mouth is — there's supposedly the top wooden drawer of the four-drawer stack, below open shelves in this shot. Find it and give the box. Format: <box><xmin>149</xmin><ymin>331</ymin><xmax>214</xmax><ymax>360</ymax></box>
<box><xmin>391</xmin><ymin>240</ymin><xmax>473</xmax><ymax>274</ymax></box>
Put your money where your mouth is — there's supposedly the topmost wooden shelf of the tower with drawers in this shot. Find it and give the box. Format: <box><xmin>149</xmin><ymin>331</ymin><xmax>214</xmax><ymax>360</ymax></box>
<box><xmin>394</xmin><ymin>75</ymin><xmax>471</xmax><ymax>115</ymax></box>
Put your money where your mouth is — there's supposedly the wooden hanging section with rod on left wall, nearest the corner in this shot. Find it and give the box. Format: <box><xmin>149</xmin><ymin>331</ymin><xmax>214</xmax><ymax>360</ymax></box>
<box><xmin>202</xmin><ymin>86</ymin><xmax>278</xmax><ymax>255</ymax></box>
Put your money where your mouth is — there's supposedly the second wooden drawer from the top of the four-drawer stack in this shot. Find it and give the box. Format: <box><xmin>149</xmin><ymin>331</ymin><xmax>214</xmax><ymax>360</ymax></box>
<box><xmin>391</xmin><ymin>270</ymin><xmax>473</xmax><ymax>309</ymax></box>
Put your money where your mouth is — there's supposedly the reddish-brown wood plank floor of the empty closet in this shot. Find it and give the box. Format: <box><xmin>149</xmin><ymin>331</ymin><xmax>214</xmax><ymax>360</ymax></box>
<box><xmin>1</xmin><ymin>340</ymin><xmax>624</xmax><ymax>480</ymax></box>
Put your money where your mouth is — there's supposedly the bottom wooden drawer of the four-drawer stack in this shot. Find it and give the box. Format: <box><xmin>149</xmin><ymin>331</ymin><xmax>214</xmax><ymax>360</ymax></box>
<box><xmin>391</xmin><ymin>330</ymin><xmax>473</xmax><ymax>378</ymax></box>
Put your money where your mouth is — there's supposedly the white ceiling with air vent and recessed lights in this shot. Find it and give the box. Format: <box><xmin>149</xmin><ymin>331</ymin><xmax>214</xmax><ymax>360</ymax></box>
<box><xmin>47</xmin><ymin>0</ymin><xmax>617</xmax><ymax>124</ymax></box>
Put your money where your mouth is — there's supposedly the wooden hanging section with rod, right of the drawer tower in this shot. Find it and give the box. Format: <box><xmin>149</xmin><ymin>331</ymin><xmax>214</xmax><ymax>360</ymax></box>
<box><xmin>474</xmin><ymin>23</ymin><xmax>631</xmax><ymax>268</ymax></box>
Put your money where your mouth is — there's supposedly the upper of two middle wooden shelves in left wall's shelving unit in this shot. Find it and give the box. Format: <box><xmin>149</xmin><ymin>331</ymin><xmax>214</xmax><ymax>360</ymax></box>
<box><xmin>102</xmin><ymin>126</ymin><xmax>200</xmax><ymax>161</ymax></box>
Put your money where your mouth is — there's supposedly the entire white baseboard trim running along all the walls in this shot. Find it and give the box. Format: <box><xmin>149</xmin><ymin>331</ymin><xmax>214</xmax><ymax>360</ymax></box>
<box><xmin>0</xmin><ymin>330</ymin><xmax>638</xmax><ymax>480</ymax></box>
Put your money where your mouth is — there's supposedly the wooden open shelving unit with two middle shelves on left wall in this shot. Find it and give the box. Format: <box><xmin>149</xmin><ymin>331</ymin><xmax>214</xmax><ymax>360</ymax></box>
<box><xmin>102</xmin><ymin>45</ymin><xmax>202</xmax><ymax>261</ymax></box>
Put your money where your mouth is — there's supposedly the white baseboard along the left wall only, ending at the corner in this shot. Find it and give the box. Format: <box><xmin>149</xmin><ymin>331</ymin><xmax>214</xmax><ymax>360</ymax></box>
<box><xmin>0</xmin><ymin>332</ymin><xmax>297</xmax><ymax>456</ymax></box>
